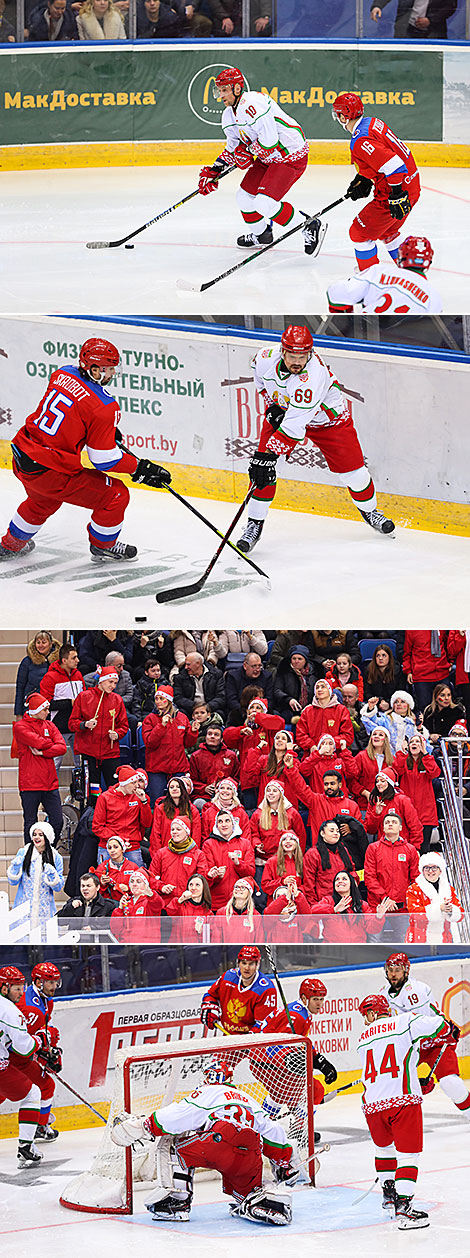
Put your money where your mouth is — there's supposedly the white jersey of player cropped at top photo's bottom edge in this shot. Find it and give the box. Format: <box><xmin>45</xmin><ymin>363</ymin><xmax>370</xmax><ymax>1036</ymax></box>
<box><xmin>327</xmin><ymin>262</ymin><xmax>442</xmax><ymax>315</ymax></box>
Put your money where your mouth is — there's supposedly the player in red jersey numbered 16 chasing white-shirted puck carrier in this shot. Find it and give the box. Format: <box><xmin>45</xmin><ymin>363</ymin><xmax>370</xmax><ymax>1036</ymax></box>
<box><xmin>333</xmin><ymin>92</ymin><xmax>420</xmax><ymax>270</ymax></box>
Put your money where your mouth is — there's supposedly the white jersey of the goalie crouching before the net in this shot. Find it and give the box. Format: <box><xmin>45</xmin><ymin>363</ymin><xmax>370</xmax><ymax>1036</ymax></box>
<box><xmin>153</xmin><ymin>1083</ymin><xmax>289</xmax><ymax>1149</ymax></box>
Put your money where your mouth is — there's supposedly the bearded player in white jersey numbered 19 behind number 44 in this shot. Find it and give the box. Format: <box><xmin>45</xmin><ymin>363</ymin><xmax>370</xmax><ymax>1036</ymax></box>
<box><xmin>380</xmin><ymin>952</ymin><xmax>470</xmax><ymax>1118</ymax></box>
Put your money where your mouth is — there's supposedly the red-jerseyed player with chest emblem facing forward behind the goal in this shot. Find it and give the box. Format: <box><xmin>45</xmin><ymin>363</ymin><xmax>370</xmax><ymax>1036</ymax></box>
<box><xmin>201</xmin><ymin>945</ymin><xmax>276</xmax><ymax>1035</ymax></box>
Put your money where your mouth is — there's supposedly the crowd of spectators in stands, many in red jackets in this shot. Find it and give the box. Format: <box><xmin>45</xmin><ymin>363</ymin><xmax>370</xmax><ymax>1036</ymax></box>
<box><xmin>8</xmin><ymin>629</ymin><xmax>470</xmax><ymax>942</ymax></box>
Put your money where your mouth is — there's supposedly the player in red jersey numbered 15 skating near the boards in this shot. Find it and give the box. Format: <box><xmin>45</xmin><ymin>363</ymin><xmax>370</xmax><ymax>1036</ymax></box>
<box><xmin>0</xmin><ymin>337</ymin><xmax>171</xmax><ymax>562</ymax></box>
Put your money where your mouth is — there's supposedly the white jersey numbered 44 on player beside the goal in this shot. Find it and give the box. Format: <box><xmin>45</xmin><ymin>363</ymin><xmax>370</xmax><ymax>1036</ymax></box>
<box><xmin>357</xmin><ymin>1013</ymin><xmax>446</xmax><ymax>1113</ymax></box>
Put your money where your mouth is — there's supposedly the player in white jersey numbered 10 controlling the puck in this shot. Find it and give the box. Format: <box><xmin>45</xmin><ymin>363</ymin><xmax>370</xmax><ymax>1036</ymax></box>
<box><xmin>199</xmin><ymin>65</ymin><xmax>327</xmax><ymax>255</ymax></box>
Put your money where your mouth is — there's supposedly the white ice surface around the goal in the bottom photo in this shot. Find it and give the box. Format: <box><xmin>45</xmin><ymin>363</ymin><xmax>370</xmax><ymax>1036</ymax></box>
<box><xmin>0</xmin><ymin>1088</ymin><xmax>470</xmax><ymax>1258</ymax></box>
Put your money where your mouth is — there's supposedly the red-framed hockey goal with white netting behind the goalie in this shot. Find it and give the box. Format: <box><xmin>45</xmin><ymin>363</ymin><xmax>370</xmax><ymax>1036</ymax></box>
<box><xmin>60</xmin><ymin>1035</ymin><xmax>314</xmax><ymax>1214</ymax></box>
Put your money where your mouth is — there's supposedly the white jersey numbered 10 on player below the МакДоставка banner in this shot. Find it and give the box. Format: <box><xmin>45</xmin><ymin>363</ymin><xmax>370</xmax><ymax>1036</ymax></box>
<box><xmin>222</xmin><ymin>92</ymin><xmax>308</xmax><ymax>162</ymax></box>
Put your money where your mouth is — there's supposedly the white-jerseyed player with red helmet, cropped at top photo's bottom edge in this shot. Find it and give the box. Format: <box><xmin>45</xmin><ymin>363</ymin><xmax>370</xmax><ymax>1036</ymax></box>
<box><xmin>327</xmin><ymin>237</ymin><xmax>442</xmax><ymax>315</ymax></box>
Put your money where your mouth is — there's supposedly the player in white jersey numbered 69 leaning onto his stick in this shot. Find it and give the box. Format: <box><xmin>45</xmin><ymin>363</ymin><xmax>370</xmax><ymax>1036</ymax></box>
<box><xmin>238</xmin><ymin>326</ymin><xmax>395</xmax><ymax>554</ymax></box>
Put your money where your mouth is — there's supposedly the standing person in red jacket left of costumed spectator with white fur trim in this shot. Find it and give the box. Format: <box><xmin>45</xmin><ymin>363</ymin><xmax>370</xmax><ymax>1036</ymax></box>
<box><xmin>364</xmin><ymin>813</ymin><xmax>420</xmax><ymax>942</ymax></box>
